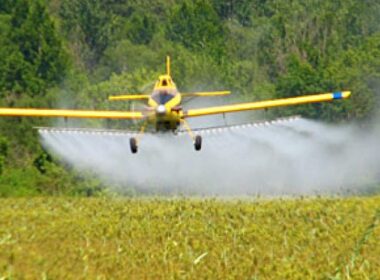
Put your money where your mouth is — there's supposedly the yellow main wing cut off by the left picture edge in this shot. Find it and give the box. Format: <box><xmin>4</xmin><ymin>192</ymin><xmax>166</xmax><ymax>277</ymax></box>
<box><xmin>0</xmin><ymin>108</ymin><xmax>144</xmax><ymax>119</ymax></box>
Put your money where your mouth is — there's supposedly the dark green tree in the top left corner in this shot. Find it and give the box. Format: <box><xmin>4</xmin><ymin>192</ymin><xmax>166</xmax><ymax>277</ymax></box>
<box><xmin>0</xmin><ymin>0</ymin><xmax>67</xmax><ymax>96</ymax></box>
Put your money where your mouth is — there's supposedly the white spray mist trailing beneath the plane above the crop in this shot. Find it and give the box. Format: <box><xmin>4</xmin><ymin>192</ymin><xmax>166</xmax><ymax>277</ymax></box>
<box><xmin>40</xmin><ymin>118</ymin><xmax>380</xmax><ymax>196</ymax></box>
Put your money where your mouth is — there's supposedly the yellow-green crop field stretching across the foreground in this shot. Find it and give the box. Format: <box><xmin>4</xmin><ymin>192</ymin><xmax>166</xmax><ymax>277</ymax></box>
<box><xmin>0</xmin><ymin>197</ymin><xmax>380</xmax><ymax>279</ymax></box>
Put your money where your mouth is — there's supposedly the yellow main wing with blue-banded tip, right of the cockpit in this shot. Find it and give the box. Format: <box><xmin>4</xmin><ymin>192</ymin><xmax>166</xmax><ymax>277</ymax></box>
<box><xmin>182</xmin><ymin>91</ymin><xmax>351</xmax><ymax>118</ymax></box>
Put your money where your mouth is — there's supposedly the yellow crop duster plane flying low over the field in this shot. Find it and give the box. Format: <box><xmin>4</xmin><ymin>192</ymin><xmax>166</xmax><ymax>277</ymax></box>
<box><xmin>0</xmin><ymin>57</ymin><xmax>351</xmax><ymax>153</ymax></box>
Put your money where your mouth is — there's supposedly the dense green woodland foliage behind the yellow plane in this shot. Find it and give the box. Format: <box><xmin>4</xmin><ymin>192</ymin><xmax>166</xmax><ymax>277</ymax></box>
<box><xmin>0</xmin><ymin>0</ymin><xmax>380</xmax><ymax>195</ymax></box>
